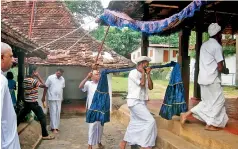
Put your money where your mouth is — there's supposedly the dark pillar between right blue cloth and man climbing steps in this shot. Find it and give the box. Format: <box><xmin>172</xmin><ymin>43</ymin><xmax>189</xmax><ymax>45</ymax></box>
<box><xmin>178</xmin><ymin>27</ymin><xmax>191</xmax><ymax>109</ymax></box>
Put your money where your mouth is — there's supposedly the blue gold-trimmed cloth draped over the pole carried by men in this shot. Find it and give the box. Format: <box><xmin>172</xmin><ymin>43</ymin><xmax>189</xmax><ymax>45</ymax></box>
<box><xmin>86</xmin><ymin>62</ymin><xmax>186</xmax><ymax>125</ymax></box>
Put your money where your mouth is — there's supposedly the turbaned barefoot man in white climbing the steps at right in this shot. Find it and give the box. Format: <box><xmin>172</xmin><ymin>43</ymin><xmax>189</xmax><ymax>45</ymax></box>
<box><xmin>181</xmin><ymin>23</ymin><xmax>228</xmax><ymax>131</ymax></box>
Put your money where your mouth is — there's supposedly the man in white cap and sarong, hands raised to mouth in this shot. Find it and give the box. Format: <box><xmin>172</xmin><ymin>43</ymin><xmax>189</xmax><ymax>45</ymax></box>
<box><xmin>120</xmin><ymin>56</ymin><xmax>157</xmax><ymax>149</ymax></box>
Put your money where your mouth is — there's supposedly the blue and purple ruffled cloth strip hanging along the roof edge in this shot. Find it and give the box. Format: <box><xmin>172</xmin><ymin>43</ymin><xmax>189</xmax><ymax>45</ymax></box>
<box><xmin>100</xmin><ymin>0</ymin><xmax>208</xmax><ymax>34</ymax></box>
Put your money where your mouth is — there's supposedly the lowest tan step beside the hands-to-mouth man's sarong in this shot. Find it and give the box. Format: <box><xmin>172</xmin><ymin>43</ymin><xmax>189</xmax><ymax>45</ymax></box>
<box><xmin>157</xmin><ymin>129</ymin><xmax>199</xmax><ymax>149</ymax></box>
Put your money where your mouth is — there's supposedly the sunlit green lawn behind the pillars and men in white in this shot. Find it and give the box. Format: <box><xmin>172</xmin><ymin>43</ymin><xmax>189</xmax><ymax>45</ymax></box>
<box><xmin>112</xmin><ymin>77</ymin><xmax>238</xmax><ymax>99</ymax></box>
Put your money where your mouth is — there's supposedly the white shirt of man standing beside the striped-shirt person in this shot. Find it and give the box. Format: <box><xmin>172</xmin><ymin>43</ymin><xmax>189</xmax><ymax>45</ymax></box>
<box><xmin>45</xmin><ymin>74</ymin><xmax>65</xmax><ymax>100</ymax></box>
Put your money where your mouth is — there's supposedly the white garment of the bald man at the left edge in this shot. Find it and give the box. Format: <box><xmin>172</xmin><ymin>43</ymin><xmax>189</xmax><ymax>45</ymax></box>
<box><xmin>0</xmin><ymin>72</ymin><xmax>21</xmax><ymax>149</ymax></box>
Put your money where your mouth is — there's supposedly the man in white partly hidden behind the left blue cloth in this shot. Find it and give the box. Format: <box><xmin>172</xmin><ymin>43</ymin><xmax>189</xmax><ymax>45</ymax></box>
<box><xmin>79</xmin><ymin>70</ymin><xmax>103</xmax><ymax>149</ymax></box>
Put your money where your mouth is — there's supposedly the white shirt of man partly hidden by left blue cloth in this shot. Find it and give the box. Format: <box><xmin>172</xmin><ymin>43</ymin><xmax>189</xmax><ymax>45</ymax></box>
<box><xmin>82</xmin><ymin>81</ymin><xmax>98</xmax><ymax>109</ymax></box>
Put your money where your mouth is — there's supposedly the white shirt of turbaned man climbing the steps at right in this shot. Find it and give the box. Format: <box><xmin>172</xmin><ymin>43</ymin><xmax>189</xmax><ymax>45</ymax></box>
<box><xmin>198</xmin><ymin>38</ymin><xmax>223</xmax><ymax>85</ymax></box>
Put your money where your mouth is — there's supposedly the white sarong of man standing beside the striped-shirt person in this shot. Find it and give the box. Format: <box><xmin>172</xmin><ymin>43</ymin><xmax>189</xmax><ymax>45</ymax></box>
<box><xmin>49</xmin><ymin>100</ymin><xmax>62</xmax><ymax>129</ymax></box>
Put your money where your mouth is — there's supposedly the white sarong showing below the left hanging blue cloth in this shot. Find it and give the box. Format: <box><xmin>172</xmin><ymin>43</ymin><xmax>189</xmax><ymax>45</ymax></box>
<box><xmin>88</xmin><ymin>121</ymin><xmax>103</xmax><ymax>145</ymax></box>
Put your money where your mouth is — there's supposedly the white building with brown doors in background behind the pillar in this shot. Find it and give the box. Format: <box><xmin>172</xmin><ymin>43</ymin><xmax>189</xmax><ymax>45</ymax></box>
<box><xmin>131</xmin><ymin>44</ymin><xmax>178</xmax><ymax>63</ymax></box>
